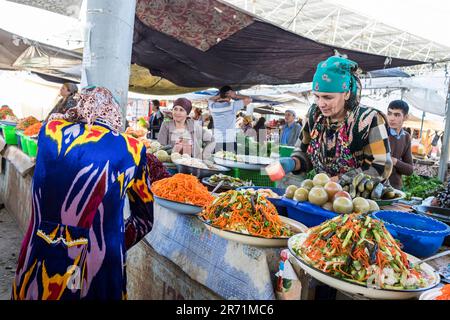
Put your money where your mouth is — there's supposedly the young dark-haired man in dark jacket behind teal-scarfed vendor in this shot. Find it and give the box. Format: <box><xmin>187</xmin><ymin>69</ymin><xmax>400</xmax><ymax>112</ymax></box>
<box><xmin>387</xmin><ymin>100</ymin><xmax>414</xmax><ymax>190</ymax></box>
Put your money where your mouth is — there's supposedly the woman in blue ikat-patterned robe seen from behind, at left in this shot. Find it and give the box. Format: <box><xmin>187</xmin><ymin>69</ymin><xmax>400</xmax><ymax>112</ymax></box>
<box><xmin>12</xmin><ymin>87</ymin><xmax>153</xmax><ymax>300</ymax></box>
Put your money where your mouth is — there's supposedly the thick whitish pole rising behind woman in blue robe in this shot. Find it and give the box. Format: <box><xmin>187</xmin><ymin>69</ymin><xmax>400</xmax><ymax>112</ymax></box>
<box><xmin>81</xmin><ymin>0</ymin><xmax>136</xmax><ymax>130</ymax></box>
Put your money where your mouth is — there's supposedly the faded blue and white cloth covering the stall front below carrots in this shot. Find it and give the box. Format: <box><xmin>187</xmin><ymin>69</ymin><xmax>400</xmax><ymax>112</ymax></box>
<box><xmin>146</xmin><ymin>203</ymin><xmax>282</xmax><ymax>300</ymax></box>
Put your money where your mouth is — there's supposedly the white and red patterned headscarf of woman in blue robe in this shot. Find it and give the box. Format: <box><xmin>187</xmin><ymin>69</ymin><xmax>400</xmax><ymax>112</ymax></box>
<box><xmin>49</xmin><ymin>87</ymin><xmax>123</xmax><ymax>132</ymax></box>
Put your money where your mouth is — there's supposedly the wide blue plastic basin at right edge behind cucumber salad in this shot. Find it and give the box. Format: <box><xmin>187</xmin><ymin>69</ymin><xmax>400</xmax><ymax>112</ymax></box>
<box><xmin>372</xmin><ymin>211</ymin><xmax>450</xmax><ymax>258</ymax></box>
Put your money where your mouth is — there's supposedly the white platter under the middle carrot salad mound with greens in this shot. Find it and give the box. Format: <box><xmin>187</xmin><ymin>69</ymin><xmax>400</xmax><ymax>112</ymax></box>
<box><xmin>198</xmin><ymin>216</ymin><xmax>308</xmax><ymax>248</ymax></box>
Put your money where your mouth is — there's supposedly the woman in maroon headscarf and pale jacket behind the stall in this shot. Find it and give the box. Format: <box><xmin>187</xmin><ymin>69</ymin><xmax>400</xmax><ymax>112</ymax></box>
<box><xmin>158</xmin><ymin>98</ymin><xmax>216</xmax><ymax>159</ymax></box>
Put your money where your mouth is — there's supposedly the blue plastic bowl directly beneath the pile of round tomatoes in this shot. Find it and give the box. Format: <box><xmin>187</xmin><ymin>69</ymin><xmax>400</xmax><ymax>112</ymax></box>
<box><xmin>281</xmin><ymin>198</ymin><xmax>338</xmax><ymax>228</ymax></box>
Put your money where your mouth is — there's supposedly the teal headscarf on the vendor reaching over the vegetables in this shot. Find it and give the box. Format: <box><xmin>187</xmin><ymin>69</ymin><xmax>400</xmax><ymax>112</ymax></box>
<box><xmin>312</xmin><ymin>56</ymin><xmax>358</xmax><ymax>94</ymax></box>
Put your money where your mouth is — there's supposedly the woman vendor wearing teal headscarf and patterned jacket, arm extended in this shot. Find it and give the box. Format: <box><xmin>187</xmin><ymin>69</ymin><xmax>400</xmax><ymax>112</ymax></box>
<box><xmin>272</xmin><ymin>56</ymin><xmax>392</xmax><ymax>181</ymax></box>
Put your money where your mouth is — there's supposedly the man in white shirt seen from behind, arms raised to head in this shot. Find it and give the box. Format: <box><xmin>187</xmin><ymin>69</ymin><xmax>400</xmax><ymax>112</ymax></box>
<box><xmin>208</xmin><ymin>86</ymin><xmax>252</xmax><ymax>152</ymax></box>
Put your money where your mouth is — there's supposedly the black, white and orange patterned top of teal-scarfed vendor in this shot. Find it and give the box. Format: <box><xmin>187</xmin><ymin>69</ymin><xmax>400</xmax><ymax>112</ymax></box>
<box><xmin>292</xmin><ymin>105</ymin><xmax>392</xmax><ymax>180</ymax></box>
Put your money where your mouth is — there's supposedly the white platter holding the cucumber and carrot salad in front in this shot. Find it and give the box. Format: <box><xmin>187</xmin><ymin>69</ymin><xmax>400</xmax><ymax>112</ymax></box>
<box><xmin>288</xmin><ymin>233</ymin><xmax>440</xmax><ymax>300</ymax></box>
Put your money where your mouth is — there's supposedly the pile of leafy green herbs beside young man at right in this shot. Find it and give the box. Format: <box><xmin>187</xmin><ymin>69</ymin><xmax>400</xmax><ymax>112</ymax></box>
<box><xmin>403</xmin><ymin>173</ymin><xmax>444</xmax><ymax>200</ymax></box>
